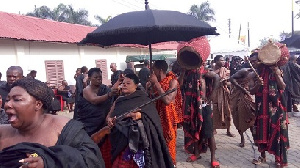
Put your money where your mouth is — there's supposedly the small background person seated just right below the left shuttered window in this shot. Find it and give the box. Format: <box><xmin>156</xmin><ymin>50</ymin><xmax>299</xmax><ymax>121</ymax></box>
<box><xmin>57</xmin><ymin>80</ymin><xmax>75</xmax><ymax>112</ymax></box>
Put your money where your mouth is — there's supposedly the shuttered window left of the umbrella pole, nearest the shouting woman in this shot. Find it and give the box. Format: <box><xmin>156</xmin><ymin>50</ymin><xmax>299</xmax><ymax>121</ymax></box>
<box><xmin>45</xmin><ymin>60</ymin><xmax>65</xmax><ymax>87</ymax></box>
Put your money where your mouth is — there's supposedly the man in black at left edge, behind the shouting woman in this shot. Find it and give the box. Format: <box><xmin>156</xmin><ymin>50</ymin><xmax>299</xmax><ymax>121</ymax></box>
<box><xmin>0</xmin><ymin>66</ymin><xmax>23</xmax><ymax>108</ymax></box>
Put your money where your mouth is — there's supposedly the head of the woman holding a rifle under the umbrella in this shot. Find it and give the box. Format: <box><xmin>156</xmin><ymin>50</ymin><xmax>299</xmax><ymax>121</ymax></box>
<box><xmin>122</xmin><ymin>74</ymin><xmax>139</xmax><ymax>95</ymax></box>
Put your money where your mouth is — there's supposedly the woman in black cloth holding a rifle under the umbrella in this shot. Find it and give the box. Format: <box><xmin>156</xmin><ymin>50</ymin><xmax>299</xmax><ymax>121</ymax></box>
<box><xmin>107</xmin><ymin>74</ymin><xmax>174</xmax><ymax>168</ymax></box>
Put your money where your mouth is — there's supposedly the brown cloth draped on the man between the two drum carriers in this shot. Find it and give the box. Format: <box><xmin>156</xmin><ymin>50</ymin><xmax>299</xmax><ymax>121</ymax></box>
<box><xmin>212</xmin><ymin>67</ymin><xmax>231</xmax><ymax>129</ymax></box>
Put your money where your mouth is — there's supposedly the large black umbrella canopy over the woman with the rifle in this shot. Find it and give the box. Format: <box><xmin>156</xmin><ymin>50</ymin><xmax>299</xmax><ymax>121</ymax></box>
<box><xmin>81</xmin><ymin>9</ymin><xmax>217</xmax><ymax>46</ymax></box>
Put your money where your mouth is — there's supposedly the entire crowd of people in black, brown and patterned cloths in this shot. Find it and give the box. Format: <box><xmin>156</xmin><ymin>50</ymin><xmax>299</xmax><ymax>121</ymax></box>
<box><xmin>0</xmin><ymin>37</ymin><xmax>300</xmax><ymax>168</ymax></box>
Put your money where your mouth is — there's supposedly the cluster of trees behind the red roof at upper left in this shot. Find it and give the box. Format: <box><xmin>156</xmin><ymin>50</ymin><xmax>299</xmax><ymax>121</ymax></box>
<box><xmin>26</xmin><ymin>3</ymin><xmax>91</xmax><ymax>26</ymax></box>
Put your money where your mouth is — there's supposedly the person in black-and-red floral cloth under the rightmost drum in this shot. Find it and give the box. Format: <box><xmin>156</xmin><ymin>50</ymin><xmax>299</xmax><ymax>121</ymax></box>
<box><xmin>249</xmin><ymin>52</ymin><xmax>289</xmax><ymax>167</ymax></box>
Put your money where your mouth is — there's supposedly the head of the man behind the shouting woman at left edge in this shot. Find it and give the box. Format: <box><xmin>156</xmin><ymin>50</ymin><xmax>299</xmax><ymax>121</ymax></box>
<box><xmin>6</xmin><ymin>66</ymin><xmax>23</xmax><ymax>86</ymax></box>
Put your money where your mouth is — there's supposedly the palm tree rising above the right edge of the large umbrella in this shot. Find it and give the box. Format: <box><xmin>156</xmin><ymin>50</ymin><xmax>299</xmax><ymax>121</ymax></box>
<box><xmin>188</xmin><ymin>1</ymin><xmax>216</xmax><ymax>22</ymax></box>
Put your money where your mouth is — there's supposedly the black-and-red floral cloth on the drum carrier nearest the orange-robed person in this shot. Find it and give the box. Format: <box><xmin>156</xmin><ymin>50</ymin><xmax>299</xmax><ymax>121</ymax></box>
<box><xmin>183</xmin><ymin>69</ymin><xmax>203</xmax><ymax>154</ymax></box>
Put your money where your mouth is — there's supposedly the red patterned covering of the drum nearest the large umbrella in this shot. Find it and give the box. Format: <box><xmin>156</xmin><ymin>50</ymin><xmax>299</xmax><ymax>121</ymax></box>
<box><xmin>177</xmin><ymin>36</ymin><xmax>210</xmax><ymax>62</ymax></box>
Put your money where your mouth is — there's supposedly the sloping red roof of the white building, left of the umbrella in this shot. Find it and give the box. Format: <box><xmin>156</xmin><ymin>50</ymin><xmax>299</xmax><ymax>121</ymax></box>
<box><xmin>0</xmin><ymin>12</ymin><xmax>96</xmax><ymax>43</ymax></box>
